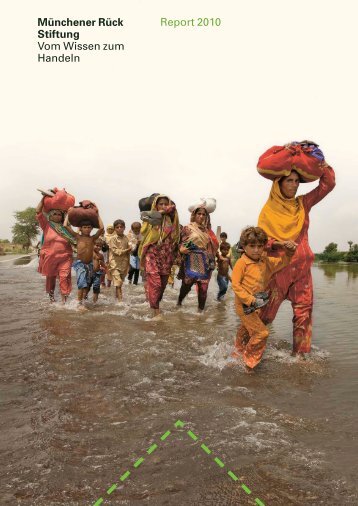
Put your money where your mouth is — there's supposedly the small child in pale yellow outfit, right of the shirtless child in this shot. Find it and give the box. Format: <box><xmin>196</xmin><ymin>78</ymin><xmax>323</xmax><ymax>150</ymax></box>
<box><xmin>108</xmin><ymin>220</ymin><xmax>132</xmax><ymax>302</ymax></box>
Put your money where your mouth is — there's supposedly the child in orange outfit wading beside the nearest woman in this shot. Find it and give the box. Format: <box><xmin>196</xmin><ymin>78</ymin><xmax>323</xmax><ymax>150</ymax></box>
<box><xmin>232</xmin><ymin>227</ymin><xmax>297</xmax><ymax>371</ymax></box>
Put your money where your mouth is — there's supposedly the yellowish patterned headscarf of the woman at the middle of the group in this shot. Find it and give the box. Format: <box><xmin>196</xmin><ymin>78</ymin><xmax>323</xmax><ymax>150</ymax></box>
<box><xmin>138</xmin><ymin>195</ymin><xmax>180</xmax><ymax>262</ymax></box>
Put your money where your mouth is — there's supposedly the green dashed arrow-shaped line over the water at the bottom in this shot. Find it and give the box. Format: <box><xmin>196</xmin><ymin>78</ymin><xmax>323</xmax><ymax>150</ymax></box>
<box><xmin>93</xmin><ymin>420</ymin><xmax>265</xmax><ymax>506</ymax></box>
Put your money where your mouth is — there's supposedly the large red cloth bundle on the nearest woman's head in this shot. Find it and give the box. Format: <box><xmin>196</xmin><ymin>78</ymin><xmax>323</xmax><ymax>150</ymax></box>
<box><xmin>257</xmin><ymin>140</ymin><xmax>325</xmax><ymax>183</ymax></box>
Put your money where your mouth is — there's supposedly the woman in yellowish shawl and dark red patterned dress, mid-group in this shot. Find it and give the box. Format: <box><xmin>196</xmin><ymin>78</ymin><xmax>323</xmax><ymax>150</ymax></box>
<box><xmin>138</xmin><ymin>195</ymin><xmax>179</xmax><ymax>318</ymax></box>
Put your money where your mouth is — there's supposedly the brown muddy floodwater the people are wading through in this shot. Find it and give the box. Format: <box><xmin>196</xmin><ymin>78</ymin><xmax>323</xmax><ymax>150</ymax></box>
<box><xmin>0</xmin><ymin>258</ymin><xmax>358</xmax><ymax>506</ymax></box>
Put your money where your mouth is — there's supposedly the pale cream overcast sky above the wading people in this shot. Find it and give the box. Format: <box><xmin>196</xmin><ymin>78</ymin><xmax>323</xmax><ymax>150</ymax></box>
<box><xmin>0</xmin><ymin>0</ymin><xmax>358</xmax><ymax>252</ymax></box>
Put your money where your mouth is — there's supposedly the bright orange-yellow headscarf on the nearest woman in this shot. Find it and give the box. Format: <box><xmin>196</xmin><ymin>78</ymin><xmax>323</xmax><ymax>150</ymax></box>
<box><xmin>258</xmin><ymin>178</ymin><xmax>305</xmax><ymax>241</ymax></box>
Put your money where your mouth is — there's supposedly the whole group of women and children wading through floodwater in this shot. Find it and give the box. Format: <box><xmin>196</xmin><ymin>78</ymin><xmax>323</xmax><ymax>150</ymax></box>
<box><xmin>37</xmin><ymin>152</ymin><xmax>335</xmax><ymax>370</ymax></box>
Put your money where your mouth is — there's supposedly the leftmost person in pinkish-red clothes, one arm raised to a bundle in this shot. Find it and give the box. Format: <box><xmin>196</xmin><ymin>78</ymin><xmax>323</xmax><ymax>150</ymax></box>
<box><xmin>36</xmin><ymin>197</ymin><xmax>76</xmax><ymax>304</ymax></box>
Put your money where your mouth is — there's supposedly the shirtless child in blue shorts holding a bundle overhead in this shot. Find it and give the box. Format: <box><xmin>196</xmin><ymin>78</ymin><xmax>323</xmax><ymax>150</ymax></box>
<box><xmin>64</xmin><ymin>211</ymin><xmax>104</xmax><ymax>310</ymax></box>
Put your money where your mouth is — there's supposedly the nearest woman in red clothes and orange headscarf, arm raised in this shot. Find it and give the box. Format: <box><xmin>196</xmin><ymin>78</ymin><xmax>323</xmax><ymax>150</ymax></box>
<box><xmin>258</xmin><ymin>164</ymin><xmax>335</xmax><ymax>355</ymax></box>
